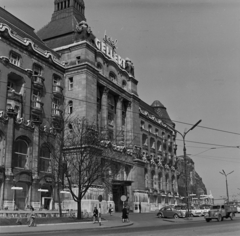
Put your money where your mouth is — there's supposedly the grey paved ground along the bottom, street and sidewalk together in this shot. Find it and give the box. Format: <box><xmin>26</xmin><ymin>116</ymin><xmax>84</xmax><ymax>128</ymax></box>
<box><xmin>0</xmin><ymin>213</ymin><xmax>240</xmax><ymax>236</ymax></box>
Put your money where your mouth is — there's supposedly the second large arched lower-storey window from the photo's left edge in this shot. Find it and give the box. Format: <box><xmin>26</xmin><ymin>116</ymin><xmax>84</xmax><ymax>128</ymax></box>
<box><xmin>13</xmin><ymin>139</ymin><xmax>28</xmax><ymax>168</ymax></box>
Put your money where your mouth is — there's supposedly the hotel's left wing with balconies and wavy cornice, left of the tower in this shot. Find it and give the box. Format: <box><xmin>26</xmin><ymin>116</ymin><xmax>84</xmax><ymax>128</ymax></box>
<box><xmin>0</xmin><ymin>8</ymin><xmax>64</xmax><ymax>209</ymax></box>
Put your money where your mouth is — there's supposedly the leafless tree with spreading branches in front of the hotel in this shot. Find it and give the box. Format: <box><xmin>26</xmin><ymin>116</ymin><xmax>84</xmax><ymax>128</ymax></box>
<box><xmin>48</xmin><ymin>117</ymin><xmax>127</xmax><ymax>219</ymax></box>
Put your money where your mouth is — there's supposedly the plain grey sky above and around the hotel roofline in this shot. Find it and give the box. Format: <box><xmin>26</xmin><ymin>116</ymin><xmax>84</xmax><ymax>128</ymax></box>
<box><xmin>0</xmin><ymin>0</ymin><xmax>240</xmax><ymax>201</ymax></box>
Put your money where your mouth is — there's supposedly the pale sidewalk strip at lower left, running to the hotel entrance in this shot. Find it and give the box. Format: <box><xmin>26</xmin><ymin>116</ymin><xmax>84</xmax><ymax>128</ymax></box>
<box><xmin>0</xmin><ymin>213</ymin><xmax>133</xmax><ymax>235</ymax></box>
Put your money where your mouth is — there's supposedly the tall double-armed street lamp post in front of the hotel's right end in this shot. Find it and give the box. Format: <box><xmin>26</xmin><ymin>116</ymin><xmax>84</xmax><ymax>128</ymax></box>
<box><xmin>165</xmin><ymin>120</ymin><xmax>202</xmax><ymax>217</ymax></box>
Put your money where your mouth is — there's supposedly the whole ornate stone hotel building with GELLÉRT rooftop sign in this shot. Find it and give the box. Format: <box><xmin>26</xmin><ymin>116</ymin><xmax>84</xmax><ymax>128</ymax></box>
<box><xmin>0</xmin><ymin>0</ymin><xmax>179</xmax><ymax>212</ymax></box>
